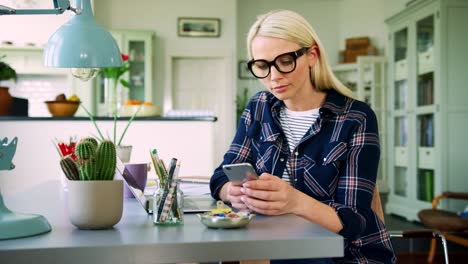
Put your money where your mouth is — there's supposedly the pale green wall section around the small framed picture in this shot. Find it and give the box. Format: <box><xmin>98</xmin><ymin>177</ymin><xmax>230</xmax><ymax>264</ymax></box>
<box><xmin>95</xmin><ymin>0</ymin><xmax>237</xmax><ymax>112</ymax></box>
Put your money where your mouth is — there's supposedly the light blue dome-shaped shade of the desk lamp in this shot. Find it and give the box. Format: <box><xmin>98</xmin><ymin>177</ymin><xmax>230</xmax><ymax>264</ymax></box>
<box><xmin>43</xmin><ymin>0</ymin><xmax>122</xmax><ymax>68</ymax></box>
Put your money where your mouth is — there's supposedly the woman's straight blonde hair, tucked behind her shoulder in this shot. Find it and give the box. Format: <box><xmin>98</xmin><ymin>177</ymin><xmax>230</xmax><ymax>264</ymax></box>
<box><xmin>247</xmin><ymin>10</ymin><xmax>354</xmax><ymax>98</ymax></box>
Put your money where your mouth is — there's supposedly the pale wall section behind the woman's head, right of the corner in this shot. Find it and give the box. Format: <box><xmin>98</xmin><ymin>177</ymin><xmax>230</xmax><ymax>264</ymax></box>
<box><xmin>237</xmin><ymin>0</ymin><xmax>408</xmax><ymax>100</ymax></box>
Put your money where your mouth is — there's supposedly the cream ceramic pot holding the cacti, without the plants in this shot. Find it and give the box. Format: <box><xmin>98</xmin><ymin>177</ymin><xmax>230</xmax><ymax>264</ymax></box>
<box><xmin>67</xmin><ymin>180</ymin><xmax>123</xmax><ymax>229</ymax></box>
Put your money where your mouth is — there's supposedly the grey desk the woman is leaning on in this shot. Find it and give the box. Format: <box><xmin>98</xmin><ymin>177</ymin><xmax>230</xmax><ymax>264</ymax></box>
<box><xmin>0</xmin><ymin>181</ymin><xmax>344</xmax><ymax>264</ymax></box>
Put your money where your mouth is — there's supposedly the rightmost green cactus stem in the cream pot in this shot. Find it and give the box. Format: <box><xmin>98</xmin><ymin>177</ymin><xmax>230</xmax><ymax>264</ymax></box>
<box><xmin>96</xmin><ymin>140</ymin><xmax>117</xmax><ymax>180</ymax></box>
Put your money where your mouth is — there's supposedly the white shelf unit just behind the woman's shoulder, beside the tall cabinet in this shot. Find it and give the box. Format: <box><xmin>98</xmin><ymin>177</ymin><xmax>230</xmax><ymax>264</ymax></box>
<box><xmin>332</xmin><ymin>56</ymin><xmax>388</xmax><ymax>192</ymax></box>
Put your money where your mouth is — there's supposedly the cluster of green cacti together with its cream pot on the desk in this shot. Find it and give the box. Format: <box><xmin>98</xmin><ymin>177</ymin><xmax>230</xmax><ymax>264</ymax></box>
<box><xmin>60</xmin><ymin>138</ymin><xmax>123</xmax><ymax>229</ymax></box>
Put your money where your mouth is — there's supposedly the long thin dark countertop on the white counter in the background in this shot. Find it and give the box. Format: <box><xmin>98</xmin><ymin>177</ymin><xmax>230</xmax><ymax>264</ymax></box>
<box><xmin>0</xmin><ymin>116</ymin><xmax>218</xmax><ymax>122</ymax></box>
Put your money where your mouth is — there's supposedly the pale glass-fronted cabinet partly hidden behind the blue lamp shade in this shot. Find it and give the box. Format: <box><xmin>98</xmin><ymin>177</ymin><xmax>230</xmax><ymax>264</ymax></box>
<box><xmin>96</xmin><ymin>30</ymin><xmax>155</xmax><ymax>115</ymax></box>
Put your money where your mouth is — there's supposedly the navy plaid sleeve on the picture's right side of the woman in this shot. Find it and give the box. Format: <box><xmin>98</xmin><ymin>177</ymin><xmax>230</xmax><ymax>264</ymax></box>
<box><xmin>330</xmin><ymin>104</ymin><xmax>380</xmax><ymax>240</ymax></box>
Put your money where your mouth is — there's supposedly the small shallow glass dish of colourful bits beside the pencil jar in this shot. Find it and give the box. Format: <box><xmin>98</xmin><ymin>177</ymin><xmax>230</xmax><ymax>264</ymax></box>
<box><xmin>197</xmin><ymin>212</ymin><xmax>255</xmax><ymax>228</ymax></box>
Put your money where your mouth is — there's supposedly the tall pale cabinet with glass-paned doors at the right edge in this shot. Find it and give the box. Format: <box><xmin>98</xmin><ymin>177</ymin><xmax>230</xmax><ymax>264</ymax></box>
<box><xmin>386</xmin><ymin>0</ymin><xmax>468</xmax><ymax>220</ymax></box>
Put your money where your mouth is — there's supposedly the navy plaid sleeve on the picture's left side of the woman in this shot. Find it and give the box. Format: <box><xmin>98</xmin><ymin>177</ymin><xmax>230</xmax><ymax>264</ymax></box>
<box><xmin>210</xmin><ymin>100</ymin><xmax>253</xmax><ymax>200</ymax></box>
